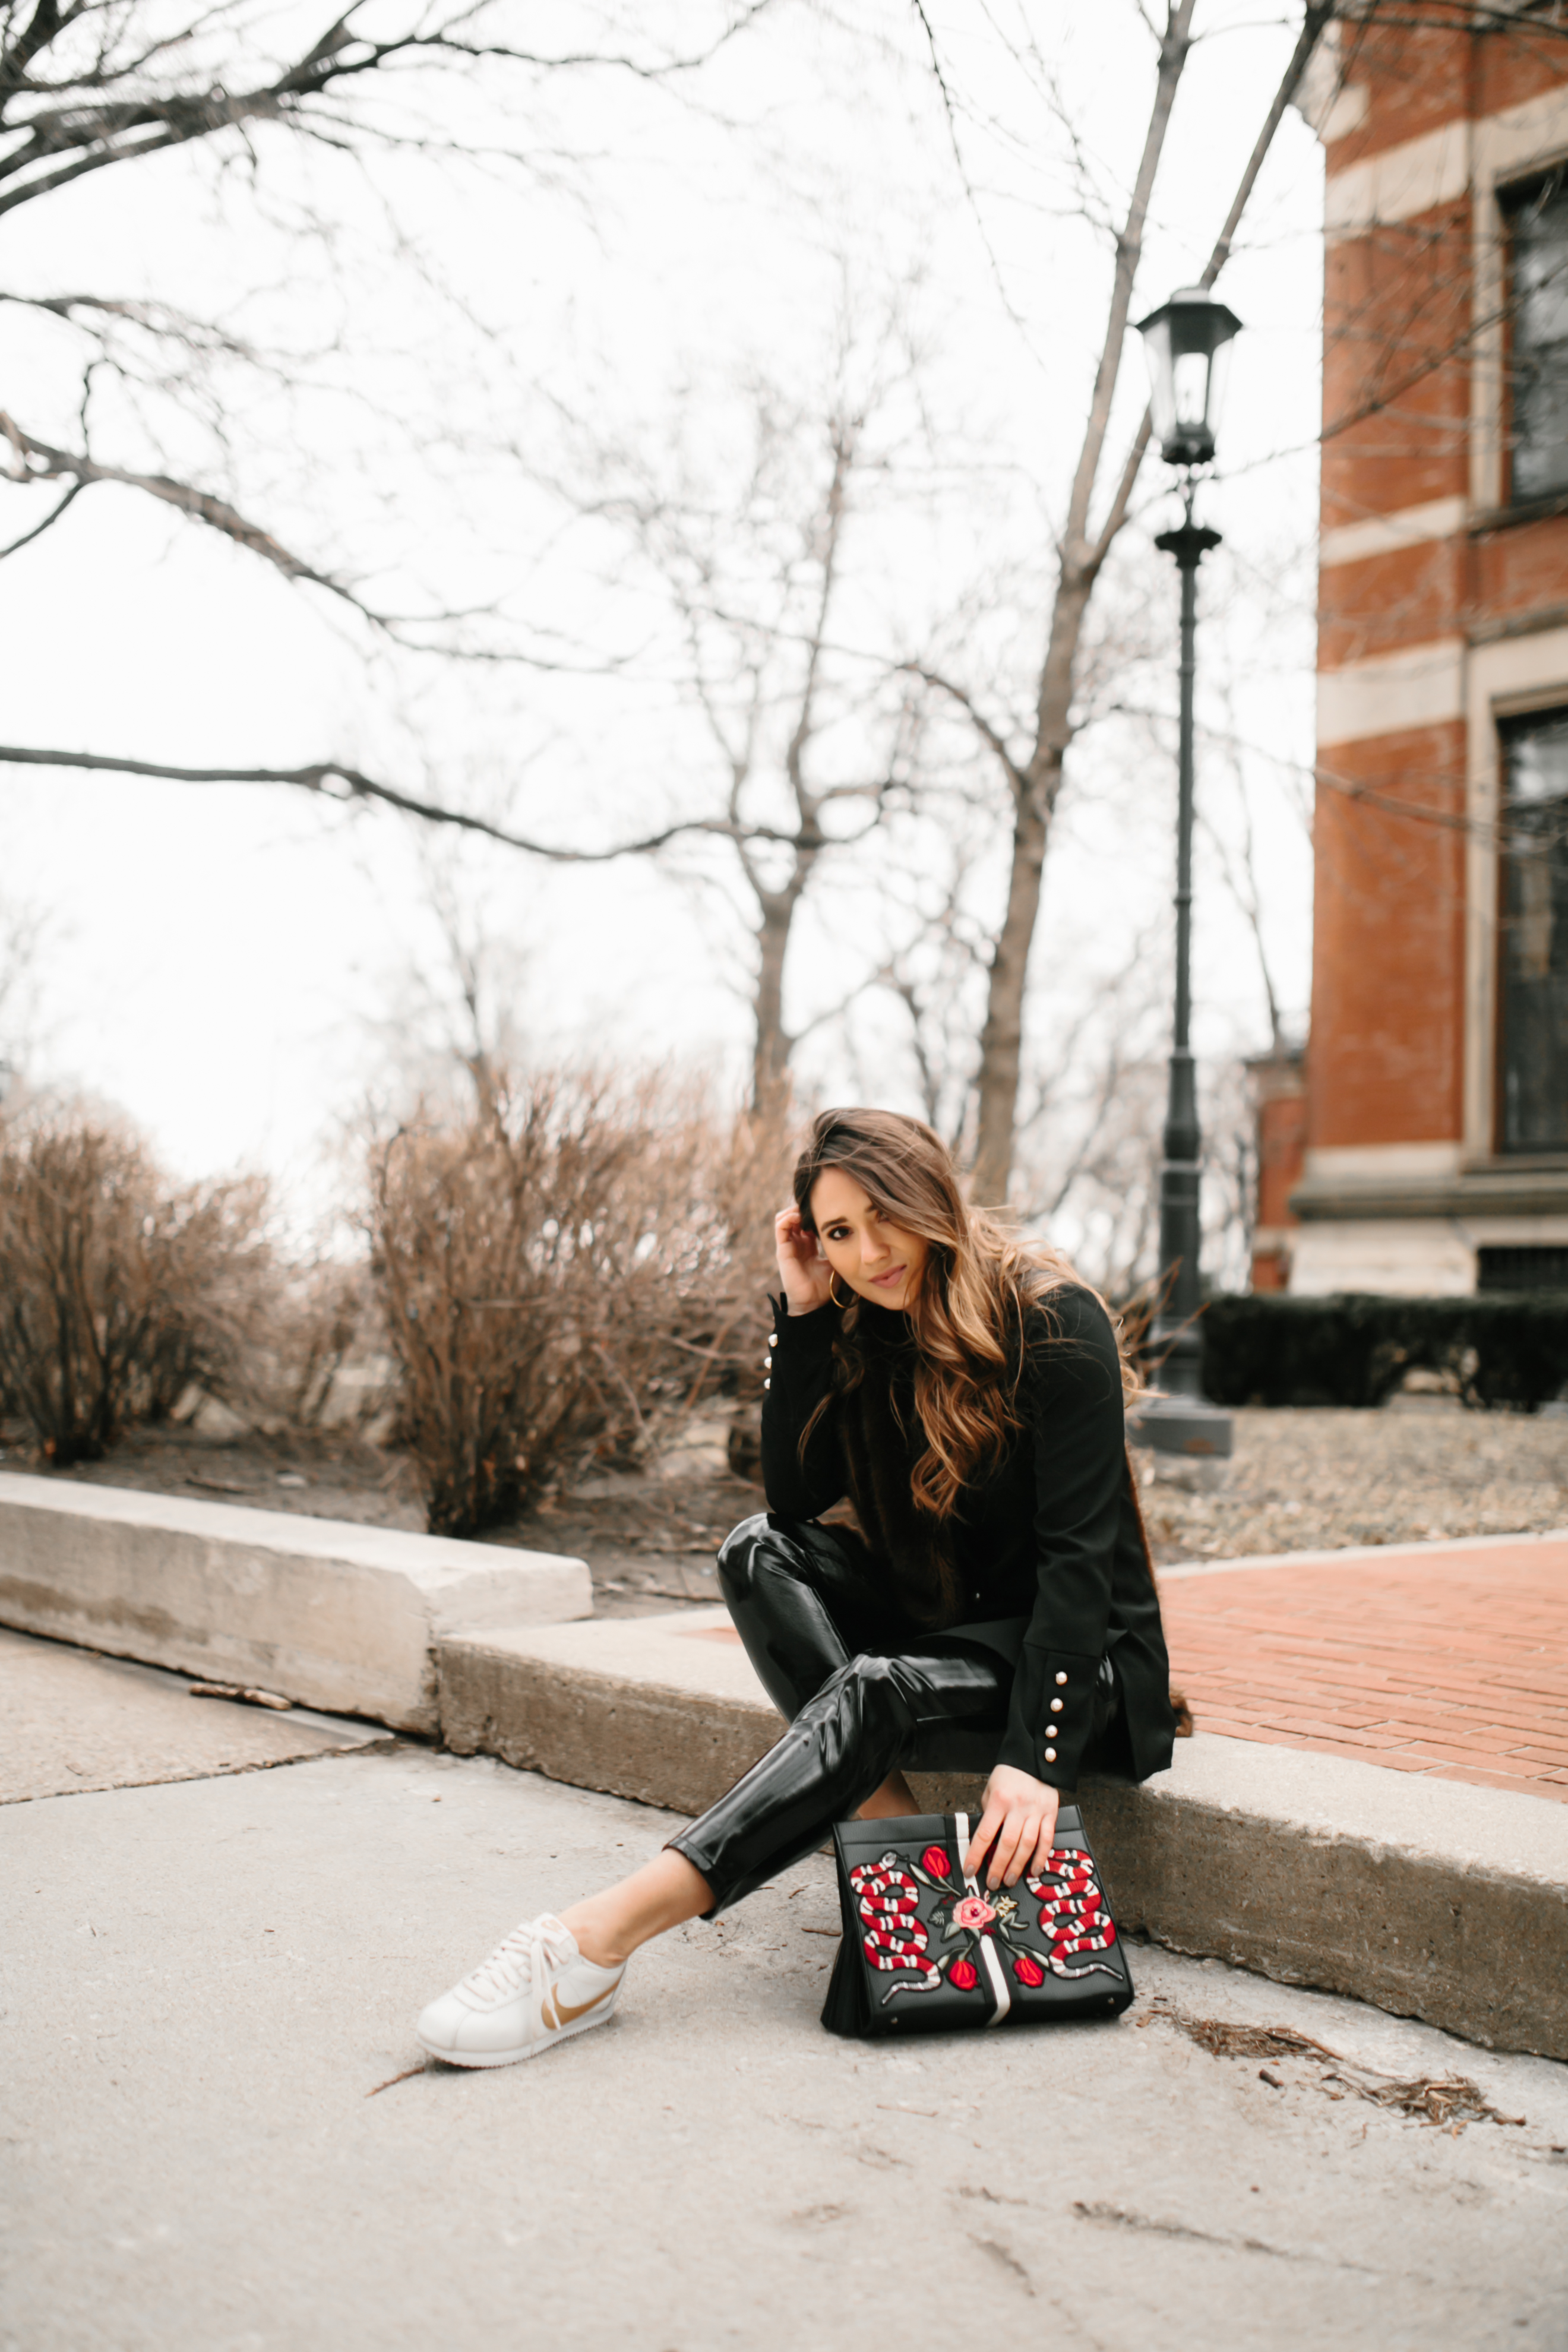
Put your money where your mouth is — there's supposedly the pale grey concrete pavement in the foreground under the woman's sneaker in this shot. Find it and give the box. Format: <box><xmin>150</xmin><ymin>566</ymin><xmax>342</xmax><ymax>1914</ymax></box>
<box><xmin>0</xmin><ymin>1642</ymin><xmax>1568</xmax><ymax>2352</ymax></box>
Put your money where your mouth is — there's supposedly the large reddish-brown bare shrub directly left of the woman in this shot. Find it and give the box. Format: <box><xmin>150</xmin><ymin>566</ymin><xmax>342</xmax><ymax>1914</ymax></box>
<box><xmin>369</xmin><ymin>1073</ymin><xmax>776</xmax><ymax>1536</ymax></box>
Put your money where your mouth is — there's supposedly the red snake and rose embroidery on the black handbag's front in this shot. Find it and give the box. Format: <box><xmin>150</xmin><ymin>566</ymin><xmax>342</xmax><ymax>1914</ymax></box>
<box><xmin>849</xmin><ymin>1847</ymin><xmax>1121</xmax><ymax>2009</ymax></box>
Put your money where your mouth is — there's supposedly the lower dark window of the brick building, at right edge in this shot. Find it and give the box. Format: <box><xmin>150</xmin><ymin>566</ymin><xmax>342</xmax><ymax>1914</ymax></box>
<box><xmin>1497</xmin><ymin>710</ymin><xmax>1568</xmax><ymax>1152</ymax></box>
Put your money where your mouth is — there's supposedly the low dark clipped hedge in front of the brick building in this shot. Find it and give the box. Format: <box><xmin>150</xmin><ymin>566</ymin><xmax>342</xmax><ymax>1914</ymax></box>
<box><xmin>1199</xmin><ymin>1291</ymin><xmax>1568</xmax><ymax>1411</ymax></box>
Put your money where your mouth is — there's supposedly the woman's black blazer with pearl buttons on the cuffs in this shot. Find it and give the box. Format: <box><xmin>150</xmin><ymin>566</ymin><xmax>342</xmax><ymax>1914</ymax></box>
<box><xmin>761</xmin><ymin>1284</ymin><xmax>1175</xmax><ymax>1790</ymax></box>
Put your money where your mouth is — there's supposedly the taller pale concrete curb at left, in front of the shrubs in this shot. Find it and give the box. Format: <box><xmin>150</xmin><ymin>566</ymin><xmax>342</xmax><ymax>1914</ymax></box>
<box><xmin>0</xmin><ymin>1472</ymin><xmax>592</xmax><ymax>1734</ymax></box>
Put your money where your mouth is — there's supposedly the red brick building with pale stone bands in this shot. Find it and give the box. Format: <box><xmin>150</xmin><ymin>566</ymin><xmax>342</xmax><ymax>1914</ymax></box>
<box><xmin>1258</xmin><ymin>0</ymin><xmax>1568</xmax><ymax>1291</ymax></box>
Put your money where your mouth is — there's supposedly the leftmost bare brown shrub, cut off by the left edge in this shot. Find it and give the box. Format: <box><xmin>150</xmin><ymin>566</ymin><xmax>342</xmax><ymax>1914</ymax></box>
<box><xmin>0</xmin><ymin>1110</ymin><xmax>270</xmax><ymax>1470</ymax></box>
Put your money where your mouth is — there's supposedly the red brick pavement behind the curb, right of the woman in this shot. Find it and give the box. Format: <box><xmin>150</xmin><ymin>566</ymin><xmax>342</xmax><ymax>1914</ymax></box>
<box><xmin>1161</xmin><ymin>1538</ymin><xmax>1568</xmax><ymax>1804</ymax></box>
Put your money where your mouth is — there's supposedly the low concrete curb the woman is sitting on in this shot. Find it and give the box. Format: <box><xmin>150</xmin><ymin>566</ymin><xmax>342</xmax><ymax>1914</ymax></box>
<box><xmin>437</xmin><ymin>1609</ymin><xmax>1568</xmax><ymax>2060</ymax></box>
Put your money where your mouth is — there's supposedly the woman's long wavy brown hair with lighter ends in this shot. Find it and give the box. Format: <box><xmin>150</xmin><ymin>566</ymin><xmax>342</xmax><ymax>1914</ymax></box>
<box><xmin>795</xmin><ymin>1110</ymin><xmax>1136</xmax><ymax>1519</ymax></box>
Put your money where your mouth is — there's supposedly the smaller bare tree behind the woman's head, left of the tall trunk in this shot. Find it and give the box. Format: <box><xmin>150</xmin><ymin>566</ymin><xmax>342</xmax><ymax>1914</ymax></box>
<box><xmin>578</xmin><ymin>336</ymin><xmax>945</xmax><ymax>1115</ymax></box>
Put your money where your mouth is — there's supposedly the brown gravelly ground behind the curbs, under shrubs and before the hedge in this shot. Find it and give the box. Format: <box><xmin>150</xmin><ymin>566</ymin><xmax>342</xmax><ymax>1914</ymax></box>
<box><xmin>18</xmin><ymin>1397</ymin><xmax>1568</xmax><ymax>1616</ymax></box>
